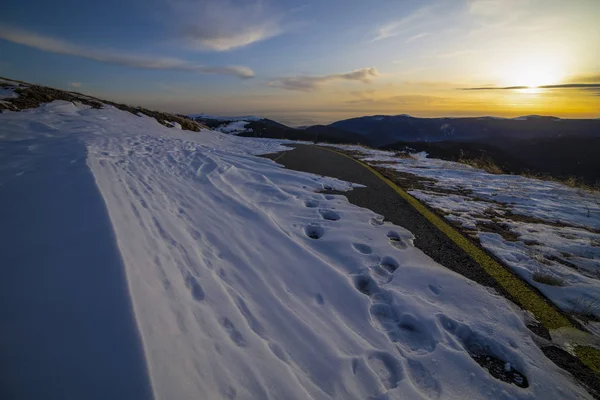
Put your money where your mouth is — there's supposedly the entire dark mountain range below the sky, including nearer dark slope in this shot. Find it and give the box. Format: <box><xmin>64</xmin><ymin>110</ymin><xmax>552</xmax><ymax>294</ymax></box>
<box><xmin>193</xmin><ymin>114</ymin><xmax>600</xmax><ymax>183</ymax></box>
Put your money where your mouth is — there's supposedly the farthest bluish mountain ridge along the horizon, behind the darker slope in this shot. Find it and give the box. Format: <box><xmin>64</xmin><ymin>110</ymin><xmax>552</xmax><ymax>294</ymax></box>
<box><xmin>192</xmin><ymin>114</ymin><xmax>600</xmax><ymax>147</ymax></box>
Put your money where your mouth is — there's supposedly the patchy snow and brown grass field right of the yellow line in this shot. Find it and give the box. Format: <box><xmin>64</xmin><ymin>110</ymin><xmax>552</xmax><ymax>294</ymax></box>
<box><xmin>326</xmin><ymin>146</ymin><xmax>600</xmax><ymax>330</ymax></box>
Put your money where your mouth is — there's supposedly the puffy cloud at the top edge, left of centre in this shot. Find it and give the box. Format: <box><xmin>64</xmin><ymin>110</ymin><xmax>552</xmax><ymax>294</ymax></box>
<box><xmin>167</xmin><ymin>0</ymin><xmax>283</xmax><ymax>51</ymax></box>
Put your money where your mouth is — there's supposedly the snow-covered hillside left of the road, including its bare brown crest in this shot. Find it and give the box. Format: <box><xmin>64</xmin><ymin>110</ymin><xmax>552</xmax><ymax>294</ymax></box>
<box><xmin>0</xmin><ymin>76</ymin><xmax>592</xmax><ymax>400</ymax></box>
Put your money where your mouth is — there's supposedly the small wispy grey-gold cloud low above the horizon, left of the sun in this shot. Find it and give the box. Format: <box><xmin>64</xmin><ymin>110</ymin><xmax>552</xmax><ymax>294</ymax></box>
<box><xmin>269</xmin><ymin>67</ymin><xmax>379</xmax><ymax>92</ymax></box>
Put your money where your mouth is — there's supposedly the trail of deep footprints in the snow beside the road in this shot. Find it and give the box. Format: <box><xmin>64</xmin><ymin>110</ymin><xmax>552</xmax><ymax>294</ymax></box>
<box><xmin>304</xmin><ymin>191</ymin><xmax>529</xmax><ymax>399</ymax></box>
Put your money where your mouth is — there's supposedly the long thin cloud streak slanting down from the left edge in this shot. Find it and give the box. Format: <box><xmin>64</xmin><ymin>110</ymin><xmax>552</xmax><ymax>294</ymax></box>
<box><xmin>0</xmin><ymin>27</ymin><xmax>254</xmax><ymax>79</ymax></box>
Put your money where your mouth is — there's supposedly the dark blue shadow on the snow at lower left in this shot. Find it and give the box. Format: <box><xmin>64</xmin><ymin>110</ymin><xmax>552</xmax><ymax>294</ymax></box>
<box><xmin>0</xmin><ymin>138</ymin><xmax>152</xmax><ymax>399</ymax></box>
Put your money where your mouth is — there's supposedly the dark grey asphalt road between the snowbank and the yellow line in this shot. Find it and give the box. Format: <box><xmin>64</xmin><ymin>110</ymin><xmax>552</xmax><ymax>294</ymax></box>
<box><xmin>268</xmin><ymin>144</ymin><xmax>511</xmax><ymax>299</ymax></box>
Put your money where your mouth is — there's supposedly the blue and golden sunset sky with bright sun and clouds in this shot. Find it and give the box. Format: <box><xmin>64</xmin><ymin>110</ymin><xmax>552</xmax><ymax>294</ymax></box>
<box><xmin>0</xmin><ymin>0</ymin><xmax>600</xmax><ymax>126</ymax></box>
